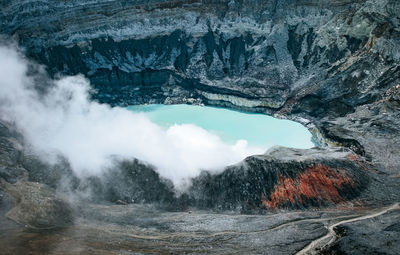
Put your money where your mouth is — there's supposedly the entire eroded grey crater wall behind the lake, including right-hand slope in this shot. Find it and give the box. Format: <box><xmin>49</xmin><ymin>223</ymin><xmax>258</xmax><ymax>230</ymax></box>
<box><xmin>0</xmin><ymin>0</ymin><xmax>400</xmax><ymax>173</ymax></box>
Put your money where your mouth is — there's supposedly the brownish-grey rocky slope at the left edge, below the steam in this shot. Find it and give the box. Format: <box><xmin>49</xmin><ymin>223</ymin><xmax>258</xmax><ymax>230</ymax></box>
<box><xmin>0</xmin><ymin>121</ymin><xmax>72</xmax><ymax>229</ymax></box>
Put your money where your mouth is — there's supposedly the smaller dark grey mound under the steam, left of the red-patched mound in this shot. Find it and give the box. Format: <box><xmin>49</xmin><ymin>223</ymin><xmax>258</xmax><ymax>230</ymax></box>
<box><xmin>76</xmin><ymin>160</ymin><xmax>178</xmax><ymax>207</ymax></box>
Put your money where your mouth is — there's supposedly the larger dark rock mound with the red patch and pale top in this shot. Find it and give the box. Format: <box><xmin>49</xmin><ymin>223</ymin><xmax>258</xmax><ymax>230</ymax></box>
<box><xmin>190</xmin><ymin>147</ymin><xmax>369</xmax><ymax>211</ymax></box>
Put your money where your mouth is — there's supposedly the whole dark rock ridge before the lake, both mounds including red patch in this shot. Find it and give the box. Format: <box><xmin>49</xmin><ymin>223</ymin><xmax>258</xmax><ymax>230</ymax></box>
<box><xmin>69</xmin><ymin>147</ymin><xmax>378</xmax><ymax>212</ymax></box>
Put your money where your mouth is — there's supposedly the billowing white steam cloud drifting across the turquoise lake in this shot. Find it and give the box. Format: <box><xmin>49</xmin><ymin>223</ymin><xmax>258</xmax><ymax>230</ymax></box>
<box><xmin>0</xmin><ymin>44</ymin><xmax>263</xmax><ymax>186</ymax></box>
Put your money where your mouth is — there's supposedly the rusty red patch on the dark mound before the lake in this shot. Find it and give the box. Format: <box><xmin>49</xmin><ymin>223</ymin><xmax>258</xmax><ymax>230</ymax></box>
<box><xmin>261</xmin><ymin>165</ymin><xmax>354</xmax><ymax>208</ymax></box>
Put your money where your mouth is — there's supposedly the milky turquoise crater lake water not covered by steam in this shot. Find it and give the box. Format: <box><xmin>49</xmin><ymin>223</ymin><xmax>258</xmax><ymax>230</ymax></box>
<box><xmin>128</xmin><ymin>104</ymin><xmax>314</xmax><ymax>148</ymax></box>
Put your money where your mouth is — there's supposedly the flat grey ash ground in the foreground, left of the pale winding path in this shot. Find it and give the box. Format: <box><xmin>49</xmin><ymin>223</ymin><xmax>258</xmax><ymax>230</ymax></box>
<box><xmin>0</xmin><ymin>203</ymin><xmax>344</xmax><ymax>254</ymax></box>
